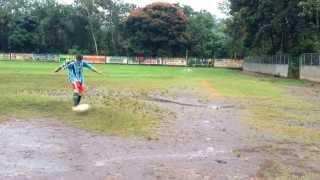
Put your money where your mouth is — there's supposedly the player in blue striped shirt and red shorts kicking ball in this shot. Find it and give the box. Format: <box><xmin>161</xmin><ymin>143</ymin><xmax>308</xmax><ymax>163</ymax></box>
<box><xmin>54</xmin><ymin>55</ymin><xmax>102</xmax><ymax>111</ymax></box>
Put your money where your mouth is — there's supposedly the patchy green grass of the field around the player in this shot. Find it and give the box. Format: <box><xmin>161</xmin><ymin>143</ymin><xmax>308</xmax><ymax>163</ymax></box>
<box><xmin>0</xmin><ymin>61</ymin><xmax>320</xmax><ymax>142</ymax></box>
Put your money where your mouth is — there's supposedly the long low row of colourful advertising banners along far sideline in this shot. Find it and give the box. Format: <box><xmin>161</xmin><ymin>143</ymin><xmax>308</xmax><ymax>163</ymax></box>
<box><xmin>0</xmin><ymin>53</ymin><xmax>243</xmax><ymax>68</ymax></box>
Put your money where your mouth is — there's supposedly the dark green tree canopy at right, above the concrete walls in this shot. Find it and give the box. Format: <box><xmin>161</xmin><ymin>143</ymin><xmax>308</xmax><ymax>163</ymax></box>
<box><xmin>229</xmin><ymin>0</ymin><xmax>320</xmax><ymax>54</ymax></box>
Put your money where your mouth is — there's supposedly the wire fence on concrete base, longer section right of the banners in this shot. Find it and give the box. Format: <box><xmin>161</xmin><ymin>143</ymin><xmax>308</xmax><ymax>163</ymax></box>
<box><xmin>243</xmin><ymin>54</ymin><xmax>291</xmax><ymax>77</ymax></box>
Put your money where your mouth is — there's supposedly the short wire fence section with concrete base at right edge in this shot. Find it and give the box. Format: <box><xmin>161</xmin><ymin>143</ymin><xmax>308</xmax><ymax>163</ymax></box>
<box><xmin>300</xmin><ymin>54</ymin><xmax>320</xmax><ymax>82</ymax></box>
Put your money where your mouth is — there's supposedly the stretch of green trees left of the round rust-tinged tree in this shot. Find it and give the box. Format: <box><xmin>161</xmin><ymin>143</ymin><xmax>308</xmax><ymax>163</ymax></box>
<box><xmin>0</xmin><ymin>0</ymin><xmax>134</xmax><ymax>55</ymax></box>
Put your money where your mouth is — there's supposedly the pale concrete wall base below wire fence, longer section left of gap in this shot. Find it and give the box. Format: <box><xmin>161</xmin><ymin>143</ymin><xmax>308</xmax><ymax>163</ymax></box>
<box><xmin>243</xmin><ymin>62</ymin><xmax>289</xmax><ymax>77</ymax></box>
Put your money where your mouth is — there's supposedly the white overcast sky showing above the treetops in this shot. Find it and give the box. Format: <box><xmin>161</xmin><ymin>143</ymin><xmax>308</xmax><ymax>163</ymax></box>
<box><xmin>58</xmin><ymin>0</ymin><xmax>226</xmax><ymax>18</ymax></box>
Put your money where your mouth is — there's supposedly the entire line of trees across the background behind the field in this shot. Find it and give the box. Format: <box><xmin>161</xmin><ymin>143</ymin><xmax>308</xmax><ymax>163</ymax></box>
<box><xmin>0</xmin><ymin>0</ymin><xmax>320</xmax><ymax>58</ymax></box>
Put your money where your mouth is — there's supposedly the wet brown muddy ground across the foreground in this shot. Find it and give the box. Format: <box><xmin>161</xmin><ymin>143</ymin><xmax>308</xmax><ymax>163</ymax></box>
<box><xmin>0</xmin><ymin>89</ymin><xmax>320</xmax><ymax>180</ymax></box>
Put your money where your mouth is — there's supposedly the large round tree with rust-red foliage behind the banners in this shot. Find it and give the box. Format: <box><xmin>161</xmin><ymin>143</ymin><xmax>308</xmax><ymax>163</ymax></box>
<box><xmin>126</xmin><ymin>3</ymin><xmax>187</xmax><ymax>56</ymax></box>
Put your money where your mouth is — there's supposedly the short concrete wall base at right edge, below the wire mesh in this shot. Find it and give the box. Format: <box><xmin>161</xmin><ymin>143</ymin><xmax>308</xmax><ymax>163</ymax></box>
<box><xmin>300</xmin><ymin>65</ymin><xmax>320</xmax><ymax>82</ymax></box>
